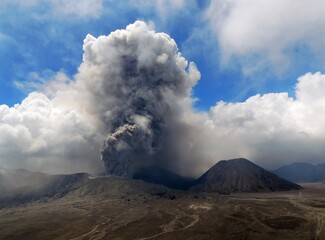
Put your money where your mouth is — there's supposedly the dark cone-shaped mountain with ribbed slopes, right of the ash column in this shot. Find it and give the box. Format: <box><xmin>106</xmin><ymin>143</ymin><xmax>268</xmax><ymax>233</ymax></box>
<box><xmin>191</xmin><ymin>158</ymin><xmax>301</xmax><ymax>194</ymax></box>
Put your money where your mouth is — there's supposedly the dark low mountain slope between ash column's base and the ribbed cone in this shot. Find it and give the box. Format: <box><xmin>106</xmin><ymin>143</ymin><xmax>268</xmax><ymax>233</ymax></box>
<box><xmin>133</xmin><ymin>166</ymin><xmax>194</xmax><ymax>190</ymax></box>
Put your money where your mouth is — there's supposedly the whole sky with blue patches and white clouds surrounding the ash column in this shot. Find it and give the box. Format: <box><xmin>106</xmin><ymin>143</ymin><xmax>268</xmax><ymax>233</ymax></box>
<box><xmin>0</xmin><ymin>0</ymin><xmax>325</xmax><ymax>174</ymax></box>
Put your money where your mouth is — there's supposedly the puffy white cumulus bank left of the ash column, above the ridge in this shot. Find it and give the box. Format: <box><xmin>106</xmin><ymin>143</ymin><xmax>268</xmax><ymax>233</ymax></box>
<box><xmin>0</xmin><ymin>92</ymin><xmax>101</xmax><ymax>172</ymax></box>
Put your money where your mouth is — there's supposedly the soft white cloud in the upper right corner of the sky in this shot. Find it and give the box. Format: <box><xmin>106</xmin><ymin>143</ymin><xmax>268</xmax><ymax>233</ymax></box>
<box><xmin>207</xmin><ymin>0</ymin><xmax>325</xmax><ymax>74</ymax></box>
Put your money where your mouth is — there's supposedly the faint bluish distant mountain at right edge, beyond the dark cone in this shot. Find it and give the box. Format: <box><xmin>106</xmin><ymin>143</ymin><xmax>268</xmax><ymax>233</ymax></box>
<box><xmin>272</xmin><ymin>162</ymin><xmax>325</xmax><ymax>182</ymax></box>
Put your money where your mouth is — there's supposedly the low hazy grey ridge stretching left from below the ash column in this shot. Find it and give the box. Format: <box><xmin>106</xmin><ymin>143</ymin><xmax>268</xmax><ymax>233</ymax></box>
<box><xmin>0</xmin><ymin>169</ymin><xmax>174</xmax><ymax>208</ymax></box>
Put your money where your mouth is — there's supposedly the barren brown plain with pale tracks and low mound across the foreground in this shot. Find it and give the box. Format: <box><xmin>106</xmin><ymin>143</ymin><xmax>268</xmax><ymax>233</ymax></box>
<box><xmin>0</xmin><ymin>177</ymin><xmax>325</xmax><ymax>240</ymax></box>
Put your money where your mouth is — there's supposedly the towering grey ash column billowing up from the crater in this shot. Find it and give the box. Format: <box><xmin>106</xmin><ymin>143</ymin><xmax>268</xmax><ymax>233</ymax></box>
<box><xmin>80</xmin><ymin>21</ymin><xmax>200</xmax><ymax>177</ymax></box>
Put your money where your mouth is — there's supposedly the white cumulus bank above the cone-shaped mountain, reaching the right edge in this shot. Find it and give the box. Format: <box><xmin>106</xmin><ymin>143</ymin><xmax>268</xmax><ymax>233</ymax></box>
<box><xmin>205</xmin><ymin>72</ymin><xmax>325</xmax><ymax>168</ymax></box>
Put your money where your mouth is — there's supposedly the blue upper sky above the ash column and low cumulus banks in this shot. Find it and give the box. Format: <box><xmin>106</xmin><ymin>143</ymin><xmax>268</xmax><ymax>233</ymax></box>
<box><xmin>0</xmin><ymin>0</ymin><xmax>324</xmax><ymax>110</ymax></box>
